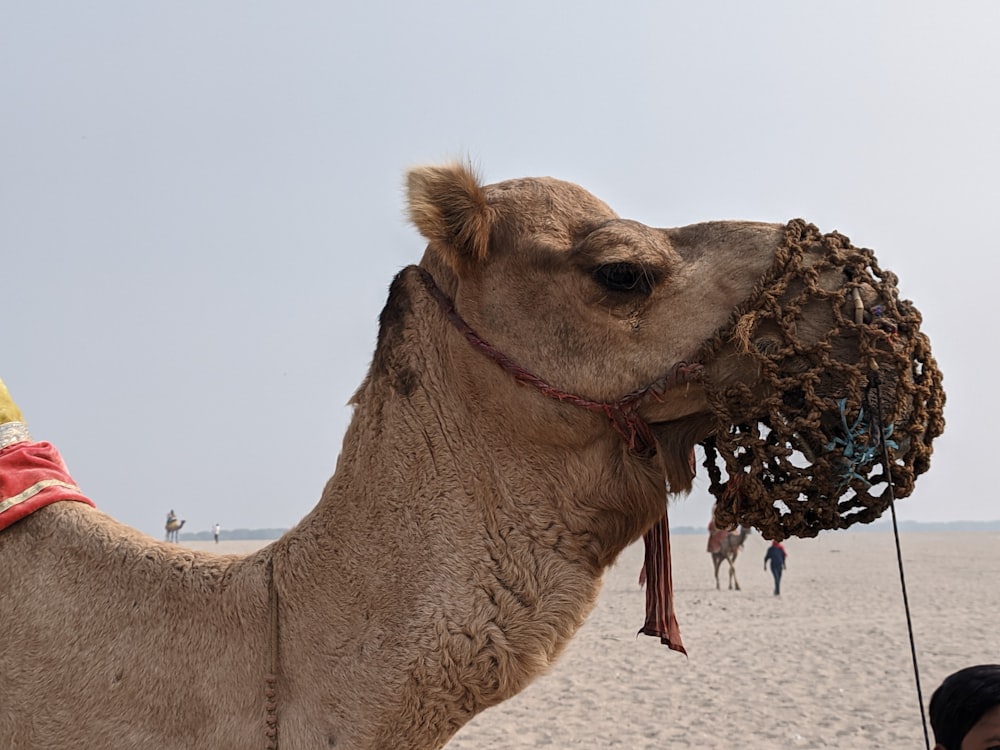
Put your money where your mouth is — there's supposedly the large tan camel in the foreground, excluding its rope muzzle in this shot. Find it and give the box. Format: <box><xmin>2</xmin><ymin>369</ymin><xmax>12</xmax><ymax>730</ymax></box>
<box><xmin>0</xmin><ymin>164</ymin><xmax>928</xmax><ymax>750</ymax></box>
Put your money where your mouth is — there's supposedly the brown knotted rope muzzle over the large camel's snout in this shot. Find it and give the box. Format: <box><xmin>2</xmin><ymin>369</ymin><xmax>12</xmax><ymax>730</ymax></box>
<box><xmin>699</xmin><ymin>219</ymin><xmax>945</xmax><ymax>539</ymax></box>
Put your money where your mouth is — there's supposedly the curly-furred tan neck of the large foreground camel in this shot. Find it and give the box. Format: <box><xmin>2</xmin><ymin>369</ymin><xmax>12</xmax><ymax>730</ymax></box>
<box><xmin>275</xmin><ymin>268</ymin><xmax>663</xmax><ymax>747</ymax></box>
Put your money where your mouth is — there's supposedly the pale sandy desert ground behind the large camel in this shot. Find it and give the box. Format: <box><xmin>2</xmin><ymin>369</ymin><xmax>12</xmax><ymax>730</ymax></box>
<box><xmin>189</xmin><ymin>532</ymin><xmax>1000</xmax><ymax>750</ymax></box>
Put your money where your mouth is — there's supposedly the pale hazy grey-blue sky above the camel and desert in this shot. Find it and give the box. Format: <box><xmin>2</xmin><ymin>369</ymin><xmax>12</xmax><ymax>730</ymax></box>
<box><xmin>0</xmin><ymin>0</ymin><xmax>1000</xmax><ymax>536</ymax></box>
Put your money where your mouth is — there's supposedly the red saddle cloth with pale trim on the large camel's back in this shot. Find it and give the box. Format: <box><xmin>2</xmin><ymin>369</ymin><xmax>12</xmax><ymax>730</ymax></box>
<box><xmin>0</xmin><ymin>442</ymin><xmax>94</xmax><ymax>530</ymax></box>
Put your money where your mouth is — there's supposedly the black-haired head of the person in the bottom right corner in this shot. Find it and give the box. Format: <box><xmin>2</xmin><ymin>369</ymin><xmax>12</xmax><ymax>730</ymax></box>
<box><xmin>930</xmin><ymin>664</ymin><xmax>1000</xmax><ymax>750</ymax></box>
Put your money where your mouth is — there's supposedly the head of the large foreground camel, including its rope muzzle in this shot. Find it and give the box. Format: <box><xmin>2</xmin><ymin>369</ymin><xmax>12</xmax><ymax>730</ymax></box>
<box><xmin>409</xmin><ymin>165</ymin><xmax>943</xmax><ymax>538</ymax></box>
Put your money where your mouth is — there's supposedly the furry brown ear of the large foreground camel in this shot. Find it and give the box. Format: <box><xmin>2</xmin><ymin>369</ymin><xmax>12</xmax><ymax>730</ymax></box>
<box><xmin>406</xmin><ymin>164</ymin><xmax>494</xmax><ymax>271</ymax></box>
